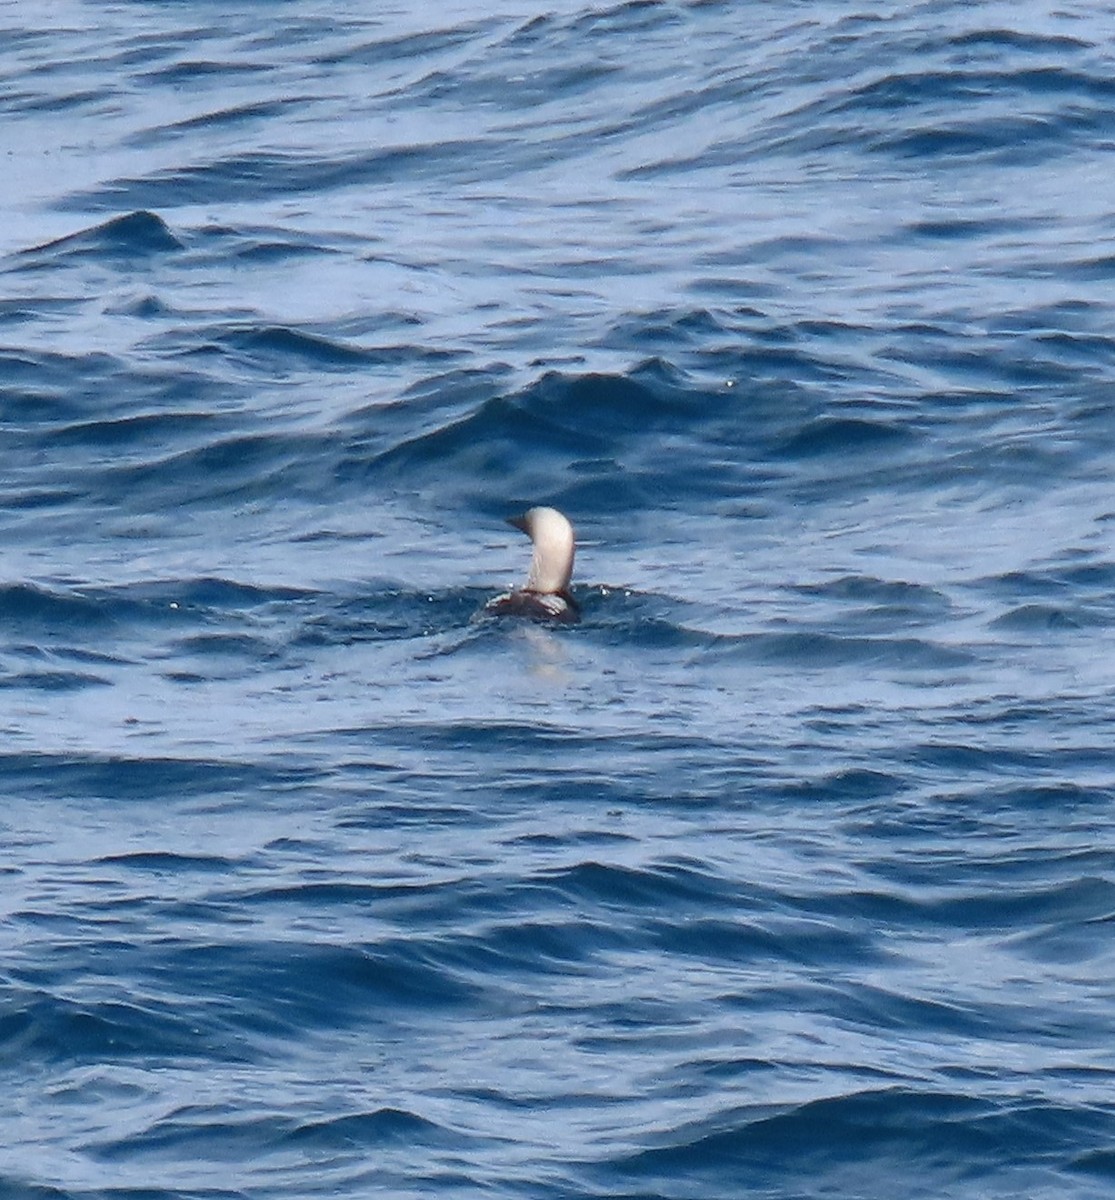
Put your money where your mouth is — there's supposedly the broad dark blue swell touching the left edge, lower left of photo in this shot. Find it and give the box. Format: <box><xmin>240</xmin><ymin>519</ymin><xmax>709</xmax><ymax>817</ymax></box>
<box><xmin>0</xmin><ymin>931</ymin><xmax>482</xmax><ymax>1064</ymax></box>
